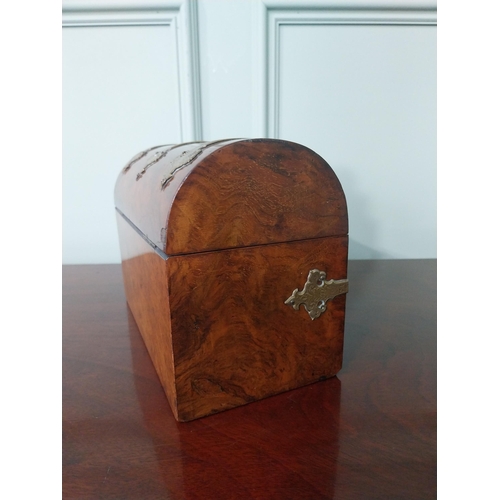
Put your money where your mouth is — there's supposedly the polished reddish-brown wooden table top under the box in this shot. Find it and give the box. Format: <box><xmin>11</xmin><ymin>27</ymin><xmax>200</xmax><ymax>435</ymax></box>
<box><xmin>63</xmin><ymin>260</ymin><xmax>436</xmax><ymax>500</ymax></box>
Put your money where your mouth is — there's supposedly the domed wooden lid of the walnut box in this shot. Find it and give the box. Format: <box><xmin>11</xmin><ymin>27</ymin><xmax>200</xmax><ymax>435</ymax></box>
<box><xmin>115</xmin><ymin>139</ymin><xmax>348</xmax><ymax>255</ymax></box>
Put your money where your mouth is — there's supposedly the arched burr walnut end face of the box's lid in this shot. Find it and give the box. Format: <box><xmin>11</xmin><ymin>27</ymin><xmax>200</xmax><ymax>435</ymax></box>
<box><xmin>165</xmin><ymin>139</ymin><xmax>348</xmax><ymax>255</ymax></box>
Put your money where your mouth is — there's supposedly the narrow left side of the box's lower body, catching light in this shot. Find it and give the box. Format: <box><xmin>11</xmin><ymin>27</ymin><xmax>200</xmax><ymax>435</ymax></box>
<box><xmin>117</xmin><ymin>213</ymin><xmax>177</xmax><ymax>418</ymax></box>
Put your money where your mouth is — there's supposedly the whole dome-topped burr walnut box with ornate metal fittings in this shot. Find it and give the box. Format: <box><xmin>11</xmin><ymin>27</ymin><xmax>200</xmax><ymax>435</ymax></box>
<box><xmin>115</xmin><ymin>139</ymin><xmax>348</xmax><ymax>421</ymax></box>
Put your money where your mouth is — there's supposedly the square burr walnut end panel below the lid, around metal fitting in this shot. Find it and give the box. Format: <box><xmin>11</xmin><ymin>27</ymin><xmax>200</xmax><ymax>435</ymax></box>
<box><xmin>167</xmin><ymin>236</ymin><xmax>348</xmax><ymax>421</ymax></box>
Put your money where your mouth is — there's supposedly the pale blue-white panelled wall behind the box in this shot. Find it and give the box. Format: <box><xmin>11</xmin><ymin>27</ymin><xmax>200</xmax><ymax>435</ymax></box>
<box><xmin>63</xmin><ymin>0</ymin><xmax>436</xmax><ymax>263</ymax></box>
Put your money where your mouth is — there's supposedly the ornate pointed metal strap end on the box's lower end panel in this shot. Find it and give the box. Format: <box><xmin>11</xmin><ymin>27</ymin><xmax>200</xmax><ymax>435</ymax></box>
<box><xmin>285</xmin><ymin>269</ymin><xmax>349</xmax><ymax>320</ymax></box>
